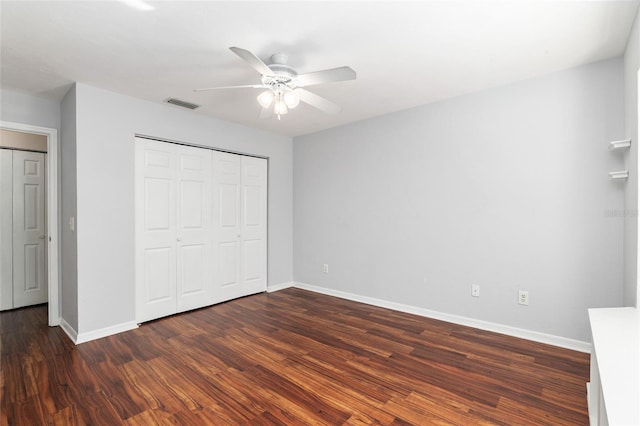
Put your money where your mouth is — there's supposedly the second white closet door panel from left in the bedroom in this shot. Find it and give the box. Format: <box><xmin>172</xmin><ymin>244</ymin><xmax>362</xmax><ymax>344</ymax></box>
<box><xmin>176</xmin><ymin>146</ymin><xmax>213</xmax><ymax>311</ymax></box>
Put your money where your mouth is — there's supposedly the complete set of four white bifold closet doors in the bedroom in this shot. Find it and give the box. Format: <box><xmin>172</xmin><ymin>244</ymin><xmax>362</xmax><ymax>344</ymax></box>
<box><xmin>135</xmin><ymin>138</ymin><xmax>267</xmax><ymax>322</ymax></box>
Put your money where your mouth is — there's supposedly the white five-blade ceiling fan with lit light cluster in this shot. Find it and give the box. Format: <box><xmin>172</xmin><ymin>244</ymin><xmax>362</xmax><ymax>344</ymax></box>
<box><xmin>194</xmin><ymin>47</ymin><xmax>356</xmax><ymax>120</ymax></box>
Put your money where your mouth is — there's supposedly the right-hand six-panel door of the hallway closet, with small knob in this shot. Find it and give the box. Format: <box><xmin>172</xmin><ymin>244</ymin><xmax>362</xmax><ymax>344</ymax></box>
<box><xmin>12</xmin><ymin>151</ymin><xmax>49</xmax><ymax>308</ymax></box>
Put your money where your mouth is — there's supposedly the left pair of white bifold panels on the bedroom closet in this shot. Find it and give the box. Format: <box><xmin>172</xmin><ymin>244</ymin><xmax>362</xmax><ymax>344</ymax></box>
<box><xmin>135</xmin><ymin>138</ymin><xmax>213</xmax><ymax>322</ymax></box>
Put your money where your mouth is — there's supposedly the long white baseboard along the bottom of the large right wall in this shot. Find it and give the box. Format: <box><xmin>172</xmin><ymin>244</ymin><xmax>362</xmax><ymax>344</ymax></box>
<box><xmin>294</xmin><ymin>282</ymin><xmax>591</xmax><ymax>353</ymax></box>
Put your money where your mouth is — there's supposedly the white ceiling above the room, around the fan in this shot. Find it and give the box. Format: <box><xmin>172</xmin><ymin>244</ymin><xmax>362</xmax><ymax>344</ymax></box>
<box><xmin>0</xmin><ymin>0</ymin><xmax>639</xmax><ymax>136</ymax></box>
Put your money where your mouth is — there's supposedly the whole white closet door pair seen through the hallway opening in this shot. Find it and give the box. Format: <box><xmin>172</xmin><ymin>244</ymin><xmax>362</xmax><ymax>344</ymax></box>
<box><xmin>0</xmin><ymin>149</ymin><xmax>49</xmax><ymax>310</ymax></box>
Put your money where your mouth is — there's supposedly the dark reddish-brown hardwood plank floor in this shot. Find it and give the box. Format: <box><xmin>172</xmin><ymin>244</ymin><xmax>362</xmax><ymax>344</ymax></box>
<box><xmin>0</xmin><ymin>289</ymin><xmax>589</xmax><ymax>425</ymax></box>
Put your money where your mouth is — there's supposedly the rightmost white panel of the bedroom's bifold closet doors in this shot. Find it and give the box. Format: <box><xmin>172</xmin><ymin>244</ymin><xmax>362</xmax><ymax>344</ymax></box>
<box><xmin>240</xmin><ymin>157</ymin><xmax>267</xmax><ymax>294</ymax></box>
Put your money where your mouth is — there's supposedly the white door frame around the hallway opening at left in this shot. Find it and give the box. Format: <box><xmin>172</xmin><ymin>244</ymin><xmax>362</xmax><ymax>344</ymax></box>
<box><xmin>0</xmin><ymin>121</ymin><xmax>61</xmax><ymax>327</ymax></box>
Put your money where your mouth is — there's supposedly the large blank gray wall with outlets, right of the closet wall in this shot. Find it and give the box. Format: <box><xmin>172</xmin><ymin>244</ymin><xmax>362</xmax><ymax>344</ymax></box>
<box><xmin>293</xmin><ymin>59</ymin><xmax>624</xmax><ymax>341</ymax></box>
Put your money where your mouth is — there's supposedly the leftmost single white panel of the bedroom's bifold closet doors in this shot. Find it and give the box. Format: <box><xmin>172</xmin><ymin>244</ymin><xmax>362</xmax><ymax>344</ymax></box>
<box><xmin>135</xmin><ymin>139</ymin><xmax>178</xmax><ymax>322</ymax></box>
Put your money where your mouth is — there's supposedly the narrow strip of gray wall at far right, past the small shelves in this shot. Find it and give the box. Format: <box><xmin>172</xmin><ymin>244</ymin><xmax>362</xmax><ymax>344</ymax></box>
<box><xmin>621</xmin><ymin>7</ymin><xmax>640</xmax><ymax>306</ymax></box>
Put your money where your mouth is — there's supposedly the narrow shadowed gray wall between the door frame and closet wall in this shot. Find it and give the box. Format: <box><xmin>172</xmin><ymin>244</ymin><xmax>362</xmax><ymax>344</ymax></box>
<box><xmin>58</xmin><ymin>85</ymin><xmax>78</xmax><ymax>331</ymax></box>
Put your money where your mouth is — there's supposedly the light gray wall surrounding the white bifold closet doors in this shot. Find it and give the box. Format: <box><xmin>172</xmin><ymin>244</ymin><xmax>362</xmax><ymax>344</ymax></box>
<box><xmin>70</xmin><ymin>84</ymin><xmax>293</xmax><ymax>333</ymax></box>
